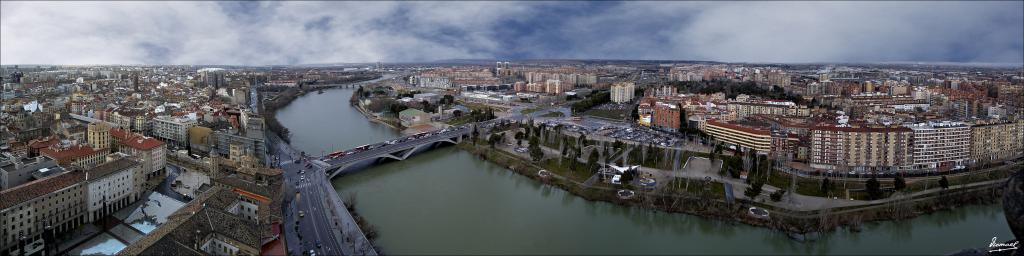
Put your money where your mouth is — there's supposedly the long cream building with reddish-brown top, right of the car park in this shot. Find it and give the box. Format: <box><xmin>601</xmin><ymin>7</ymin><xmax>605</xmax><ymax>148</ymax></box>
<box><xmin>705</xmin><ymin>120</ymin><xmax>772</xmax><ymax>154</ymax></box>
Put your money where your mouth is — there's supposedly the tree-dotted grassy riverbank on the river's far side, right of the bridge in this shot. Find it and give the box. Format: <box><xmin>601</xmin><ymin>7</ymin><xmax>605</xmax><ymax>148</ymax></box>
<box><xmin>459</xmin><ymin>142</ymin><xmax>1002</xmax><ymax>237</ymax></box>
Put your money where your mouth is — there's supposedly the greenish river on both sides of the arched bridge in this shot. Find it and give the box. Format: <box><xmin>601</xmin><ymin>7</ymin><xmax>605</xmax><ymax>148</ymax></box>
<box><xmin>278</xmin><ymin>89</ymin><xmax>1013</xmax><ymax>255</ymax></box>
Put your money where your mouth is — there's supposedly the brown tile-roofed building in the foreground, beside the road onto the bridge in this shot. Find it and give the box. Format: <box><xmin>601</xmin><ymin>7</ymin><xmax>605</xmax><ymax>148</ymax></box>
<box><xmin>119</xmin><ymin>165</ymin><xmax>285</xmax><ymax>255</ymax></box>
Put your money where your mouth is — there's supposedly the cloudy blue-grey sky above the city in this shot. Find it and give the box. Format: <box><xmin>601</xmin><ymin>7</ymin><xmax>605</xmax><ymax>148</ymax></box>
<box><xmin>0</xmin><ymin>1</ymin><xmax>1024</xmax><ymax>65</ymax></box>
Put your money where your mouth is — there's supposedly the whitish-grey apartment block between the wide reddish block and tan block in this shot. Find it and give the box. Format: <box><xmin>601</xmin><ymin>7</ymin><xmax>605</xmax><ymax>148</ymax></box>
<box><xmin>906</xmin><ymin>121</ymin><xmax>971</xmax><ymax>171</ymax></box>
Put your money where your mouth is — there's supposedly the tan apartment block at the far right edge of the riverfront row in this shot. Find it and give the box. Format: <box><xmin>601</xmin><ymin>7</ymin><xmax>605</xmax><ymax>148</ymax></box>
<box><xmin>971</xmin><ymin>120</ymin><xmax>1024</xmax><ymax>164</ymax></box>
